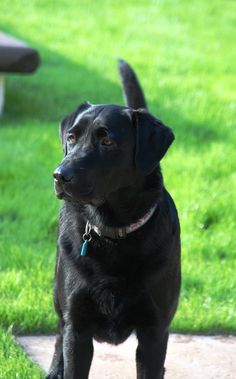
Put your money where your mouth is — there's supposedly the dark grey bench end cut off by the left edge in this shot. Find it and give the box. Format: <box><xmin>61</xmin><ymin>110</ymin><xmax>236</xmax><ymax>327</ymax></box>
<box><xmin>0</xmin><ymin>32</ymin><xmax>40</xmax><ymax>115</ymax></box>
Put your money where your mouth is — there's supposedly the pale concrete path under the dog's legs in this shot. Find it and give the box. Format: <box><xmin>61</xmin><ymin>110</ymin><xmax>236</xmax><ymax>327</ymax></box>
<box><xmin>18</xmin><ymin>334</ymin><xmax>236</xmax><ymax>379</ymax></box>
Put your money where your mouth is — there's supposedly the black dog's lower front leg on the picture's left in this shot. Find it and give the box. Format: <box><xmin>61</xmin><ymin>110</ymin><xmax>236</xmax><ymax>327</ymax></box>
<box><xmin>63</xmin><ymin>324</ymin><xmax>93</xmax><ymax>379</ymax></box>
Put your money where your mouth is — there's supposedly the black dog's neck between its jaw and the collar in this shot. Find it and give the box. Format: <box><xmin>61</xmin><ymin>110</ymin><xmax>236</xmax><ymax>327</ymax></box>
<box><xmin>83</xmin><ymin>170</ymin><xmax>163</xmax><ymax>228</ymax></box>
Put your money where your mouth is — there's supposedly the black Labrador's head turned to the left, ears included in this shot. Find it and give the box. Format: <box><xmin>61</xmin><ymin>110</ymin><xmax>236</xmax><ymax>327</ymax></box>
<box><xmin>54</xmin><ymin>103</ymin><xmax>174</xmax><ymax>203</ymax></box>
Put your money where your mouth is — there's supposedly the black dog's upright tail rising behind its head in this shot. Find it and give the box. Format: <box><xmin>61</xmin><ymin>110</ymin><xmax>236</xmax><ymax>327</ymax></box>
<box><xmin>118</xmin><ymin>59</ymin><xmax>147</xmax><ymax>109</ymax></box>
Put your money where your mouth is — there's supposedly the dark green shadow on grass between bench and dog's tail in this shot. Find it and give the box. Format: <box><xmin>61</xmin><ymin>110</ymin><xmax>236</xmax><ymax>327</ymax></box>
<box><xmin>4</xmin><ymin>48</ymin><xmax>122</xmax><ymax>124</ymax></box>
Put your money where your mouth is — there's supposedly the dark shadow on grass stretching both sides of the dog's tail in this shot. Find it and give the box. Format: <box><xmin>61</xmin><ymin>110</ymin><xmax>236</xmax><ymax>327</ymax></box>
<box><xmin>2</xmin><ymin>29</ymin><xmax>225</xmax><ymax>151</ymax></box>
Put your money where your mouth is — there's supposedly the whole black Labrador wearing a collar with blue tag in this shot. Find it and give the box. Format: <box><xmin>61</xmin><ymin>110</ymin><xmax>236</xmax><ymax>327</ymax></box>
<box><xmin>47</xmin><ymin>61</ymin><xmax>180</xmax><ymax>379</ymax></box>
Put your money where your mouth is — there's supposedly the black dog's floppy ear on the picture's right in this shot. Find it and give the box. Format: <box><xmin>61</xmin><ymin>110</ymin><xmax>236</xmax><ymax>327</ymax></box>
<box><xmin>133</xmin><ymin>109</ymin><xmax>175</xmax><ymax>176</ymax></box>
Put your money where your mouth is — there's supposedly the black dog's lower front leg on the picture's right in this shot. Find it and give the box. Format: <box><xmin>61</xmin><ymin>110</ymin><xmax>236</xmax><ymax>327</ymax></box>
<box><xmin>136</xmin><ymin>328</ymin><xmax>169</xmax><ymax>379</ymax></box>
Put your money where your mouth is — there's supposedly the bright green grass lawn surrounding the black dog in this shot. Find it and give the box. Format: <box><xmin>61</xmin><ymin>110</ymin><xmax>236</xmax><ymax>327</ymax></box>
<box><xmin>0</xmin><ymin>0</ymin><xmax>236</xmax><ymax>379</ymax></box>
